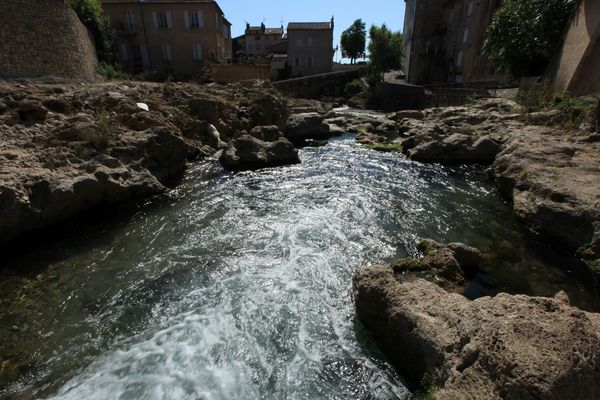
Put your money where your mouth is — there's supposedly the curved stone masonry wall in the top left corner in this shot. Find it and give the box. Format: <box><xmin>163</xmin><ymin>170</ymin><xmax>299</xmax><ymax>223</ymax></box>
<box><xmin>0</xmin><ymin>0</ymin><xmax>97</xmax><ymax>80</ymax></box>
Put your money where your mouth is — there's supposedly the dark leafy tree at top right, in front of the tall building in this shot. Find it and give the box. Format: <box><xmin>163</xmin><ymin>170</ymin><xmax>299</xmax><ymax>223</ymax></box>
<box><xmin>483</xmin><ymin>0</ymin><xmax>576</xmax><ymax>77</ymax></box>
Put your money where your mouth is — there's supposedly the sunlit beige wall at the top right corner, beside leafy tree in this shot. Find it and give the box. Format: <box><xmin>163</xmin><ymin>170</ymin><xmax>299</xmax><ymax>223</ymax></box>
<box><xmin>554</xmin><ymin>0</ymin><xmax>600</xmax><ymax>95</ymax></box>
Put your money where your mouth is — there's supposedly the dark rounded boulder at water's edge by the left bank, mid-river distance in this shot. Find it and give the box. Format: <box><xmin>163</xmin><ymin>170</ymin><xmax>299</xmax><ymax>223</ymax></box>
<box><xmin>220</xmin><ymin>130</ymin><xmax>300</xmax><ymax>171</ymax></box>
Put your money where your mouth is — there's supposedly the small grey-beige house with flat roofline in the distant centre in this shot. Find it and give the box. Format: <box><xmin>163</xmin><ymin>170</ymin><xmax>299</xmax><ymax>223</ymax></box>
<box><xmin>287</xmin><ymin>18</ymin><xmax>334</xmax><ymax>76</ymax></box>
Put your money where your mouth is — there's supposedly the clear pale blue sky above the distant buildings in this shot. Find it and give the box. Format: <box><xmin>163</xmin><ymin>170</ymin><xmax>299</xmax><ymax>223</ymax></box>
<box><xmin>217</xmin><ymin>0</ymin><xmax>405</xmax><ymax>62</ymax></box>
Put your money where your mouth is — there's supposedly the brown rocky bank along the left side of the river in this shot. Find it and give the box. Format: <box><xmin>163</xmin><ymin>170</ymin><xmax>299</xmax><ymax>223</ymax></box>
<box><xmin>0</xmin><ymin>78</ymin><xmax>293</xmax><ymax>244</ymax></box>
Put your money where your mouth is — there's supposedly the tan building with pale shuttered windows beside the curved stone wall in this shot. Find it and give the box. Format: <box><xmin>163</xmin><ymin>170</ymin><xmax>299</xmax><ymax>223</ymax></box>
<box><xmin>101</xmin><ymin>0</ymin><xmax>232</xmax><ymax>77</ymax></box>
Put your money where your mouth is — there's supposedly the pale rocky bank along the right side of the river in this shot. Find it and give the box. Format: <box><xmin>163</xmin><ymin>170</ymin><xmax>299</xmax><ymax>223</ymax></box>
<box><xmin>325</xmin><ymin>98</ymin><xmax>600</xmax><ymax>274</ymax></box>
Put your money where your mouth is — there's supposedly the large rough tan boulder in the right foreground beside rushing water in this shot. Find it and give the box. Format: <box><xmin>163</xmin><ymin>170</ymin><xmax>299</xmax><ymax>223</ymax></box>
<box><xmin>353</xmin><ymin>267</ymin><xmax>600</xmax><ymax>400</ymax></box>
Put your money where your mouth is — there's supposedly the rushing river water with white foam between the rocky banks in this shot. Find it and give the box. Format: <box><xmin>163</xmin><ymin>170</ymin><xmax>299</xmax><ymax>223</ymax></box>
<box><xmin>0</xmin><ymin>137</ymin><xmax>598</xmax><ymax>399</ymax></box>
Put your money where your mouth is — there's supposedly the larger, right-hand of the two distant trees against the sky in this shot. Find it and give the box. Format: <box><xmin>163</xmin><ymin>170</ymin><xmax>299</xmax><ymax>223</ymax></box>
<box><xmin>369</xmin><ymin>24</ymin><xmax>404</xmax><ymax>80</ymax></box>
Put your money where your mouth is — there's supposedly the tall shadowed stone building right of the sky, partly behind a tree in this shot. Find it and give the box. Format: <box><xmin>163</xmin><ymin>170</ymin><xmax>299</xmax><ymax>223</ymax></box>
<box><xmin>404</xmin><ymin>0</ymin><xmax>508</xmax><ymax>84</ymax></box>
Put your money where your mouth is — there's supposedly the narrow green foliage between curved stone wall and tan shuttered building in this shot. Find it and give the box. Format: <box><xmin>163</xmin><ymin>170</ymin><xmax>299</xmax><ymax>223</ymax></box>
<box><xmin>69</xmin><ymin>0</ymin><xmax>115</xmax><ymax>63</ymax></box>
